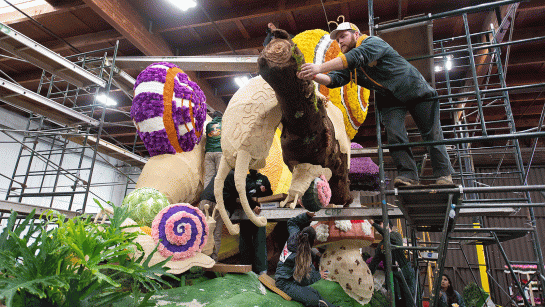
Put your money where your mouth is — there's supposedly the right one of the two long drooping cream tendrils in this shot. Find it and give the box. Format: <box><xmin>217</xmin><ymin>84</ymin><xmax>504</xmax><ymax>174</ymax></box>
<box><xmin>235</xmin><ymin>150</ymin><xmax>267</xmax><ymax>227</ymax></box>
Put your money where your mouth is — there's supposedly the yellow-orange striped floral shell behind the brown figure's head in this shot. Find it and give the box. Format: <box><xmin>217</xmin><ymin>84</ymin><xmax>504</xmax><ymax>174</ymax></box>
<box><xmin>293</xmin><ymin>29</ymin><xmax>370</xmax><ymax>139</ymax></box>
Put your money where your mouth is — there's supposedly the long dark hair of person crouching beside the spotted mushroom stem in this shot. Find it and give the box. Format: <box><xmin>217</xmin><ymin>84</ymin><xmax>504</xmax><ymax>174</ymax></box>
<box><xmin>293</xmin><ymin>226</ymin><xmax>316</xmax><ymax>282</ymax></box>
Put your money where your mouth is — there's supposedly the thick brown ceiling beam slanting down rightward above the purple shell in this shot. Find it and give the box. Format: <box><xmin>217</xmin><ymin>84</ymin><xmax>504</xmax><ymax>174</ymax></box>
<box><xmin>84</xmin><ymin>0</ymin><xmax>226</xmax><ymax>111</ymax></box>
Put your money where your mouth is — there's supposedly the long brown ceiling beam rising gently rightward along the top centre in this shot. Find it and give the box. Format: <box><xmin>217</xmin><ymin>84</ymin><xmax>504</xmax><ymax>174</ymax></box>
<box><xmin>155</xmin><ymin>0</ymin><xmax>359</xmax><ymax>33</ymax></box>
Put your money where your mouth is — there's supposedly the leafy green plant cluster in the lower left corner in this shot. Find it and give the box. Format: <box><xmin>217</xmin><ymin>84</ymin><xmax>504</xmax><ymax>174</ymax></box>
<box><xmin>0</xmin><ymin>200</ymin><xmax>176</xmax><ymax>307</ymax></box>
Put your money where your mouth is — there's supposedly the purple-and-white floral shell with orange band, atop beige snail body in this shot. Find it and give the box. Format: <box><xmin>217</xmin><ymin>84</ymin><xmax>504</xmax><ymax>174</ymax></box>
<box><xmin>131</xmin><ymin>62</ymin><xmax>206</xmax><ymax>156</ymax></box>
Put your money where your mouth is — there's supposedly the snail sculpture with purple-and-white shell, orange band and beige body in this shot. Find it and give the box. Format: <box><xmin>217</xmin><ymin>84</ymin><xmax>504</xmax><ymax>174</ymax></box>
<box><xmin>131</xmin><ymin>62</ymin><xmax>207</xmax><ymax>204</ymax></box>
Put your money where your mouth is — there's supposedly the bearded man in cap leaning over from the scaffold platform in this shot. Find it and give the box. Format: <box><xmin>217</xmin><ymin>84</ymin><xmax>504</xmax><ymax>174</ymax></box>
<box><xmin>297</xmin><ymin>22</ymin><xmax>454</xmax><ymax>187</ymax></box>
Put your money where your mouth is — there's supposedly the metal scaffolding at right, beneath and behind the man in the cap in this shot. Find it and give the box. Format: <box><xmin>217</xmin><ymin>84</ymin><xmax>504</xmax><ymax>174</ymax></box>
<box><xmin>368</xmin><ymin>0</ymin><xmax>545</xmax><ymax>306</ymax></box>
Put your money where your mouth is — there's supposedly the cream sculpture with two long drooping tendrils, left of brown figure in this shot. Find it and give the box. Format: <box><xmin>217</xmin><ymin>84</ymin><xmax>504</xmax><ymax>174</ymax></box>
<box><xmin>214</xmin><ymin>77</ymin><xmax>282</xmax><ymax>235</ymax></box>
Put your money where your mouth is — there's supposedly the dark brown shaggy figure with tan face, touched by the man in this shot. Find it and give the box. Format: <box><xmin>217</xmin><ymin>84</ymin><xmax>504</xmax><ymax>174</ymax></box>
<box><xmin>258</xmin><ymin>30</ymin><xmax>352</xmax><ymax>205</ymax></box>
